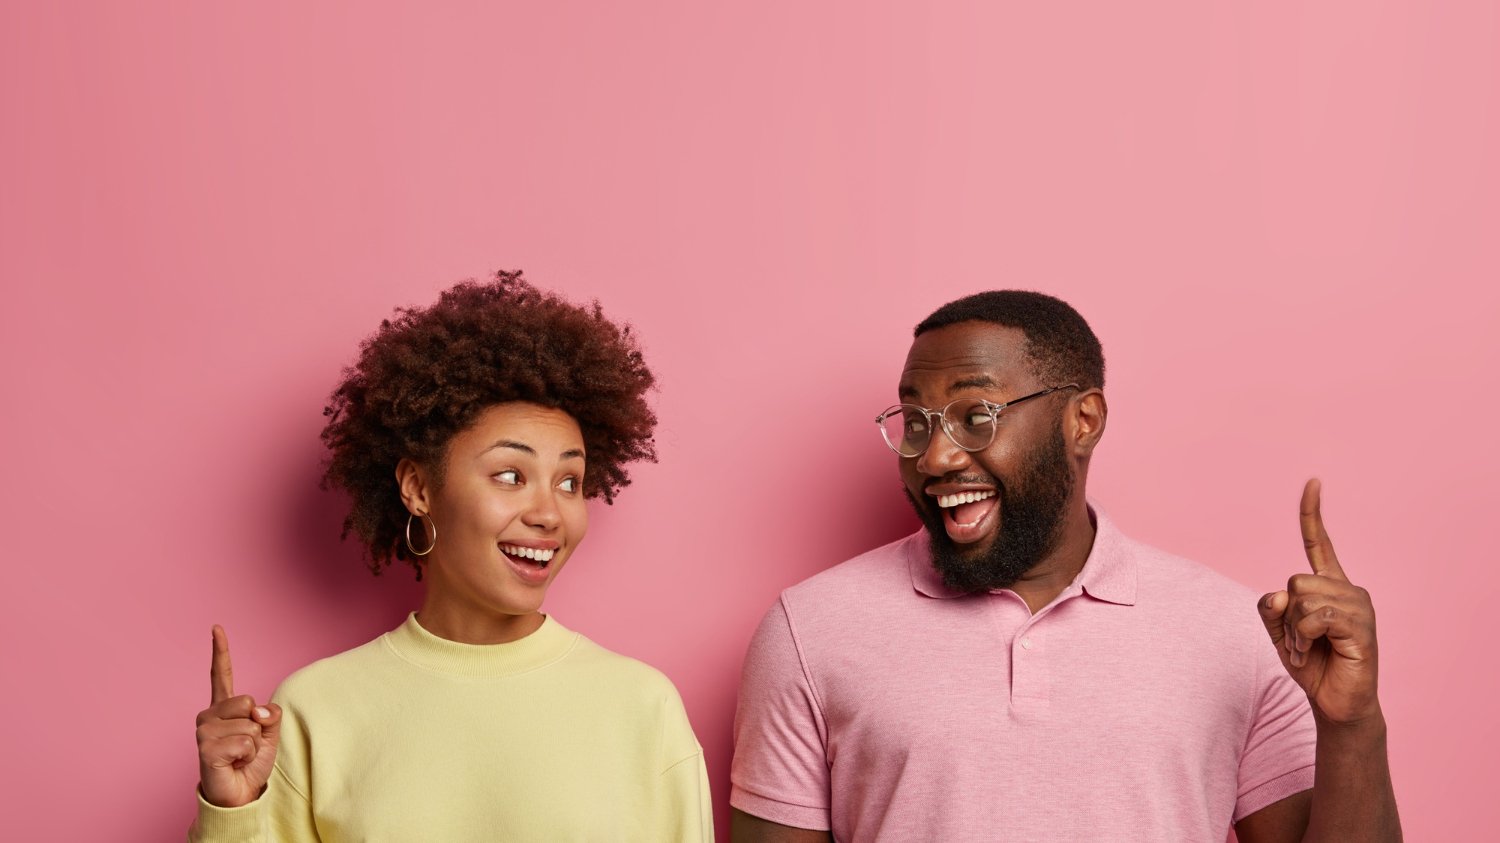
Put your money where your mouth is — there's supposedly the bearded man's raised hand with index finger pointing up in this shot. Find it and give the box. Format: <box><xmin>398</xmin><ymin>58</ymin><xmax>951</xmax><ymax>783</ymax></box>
<box><xmin>1260</xmin><ymin>480</ymin><xmax>1380</xmax><ymax>725</ymax></box>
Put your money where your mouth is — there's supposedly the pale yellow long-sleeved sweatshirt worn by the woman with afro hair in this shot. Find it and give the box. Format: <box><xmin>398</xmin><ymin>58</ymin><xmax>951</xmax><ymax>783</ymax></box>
<box><xmin>188</xmin><ymin>615</ymin><xmax>714</xmax><ymax>843</ymax></box>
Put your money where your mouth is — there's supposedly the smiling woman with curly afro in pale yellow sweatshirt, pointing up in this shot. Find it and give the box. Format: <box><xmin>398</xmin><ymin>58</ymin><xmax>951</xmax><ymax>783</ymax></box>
<box><xmin>189</xmin><ymin>273</ymin><xmax>713</xmax><ymax>842</ymax></box>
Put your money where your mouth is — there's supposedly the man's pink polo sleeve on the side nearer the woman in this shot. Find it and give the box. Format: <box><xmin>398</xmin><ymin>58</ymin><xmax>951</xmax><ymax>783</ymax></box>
<box><xmin>729</xmin><ymin>597</ymin><xmax>830</xmax><ymax>831</ymax></box>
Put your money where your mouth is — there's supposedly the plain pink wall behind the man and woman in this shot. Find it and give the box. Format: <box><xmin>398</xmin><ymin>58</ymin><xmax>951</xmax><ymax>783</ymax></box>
<box><xmin>0</xmin><ymin>0</ymin><xmax>1500</xmax><ymax>842</ymax></box>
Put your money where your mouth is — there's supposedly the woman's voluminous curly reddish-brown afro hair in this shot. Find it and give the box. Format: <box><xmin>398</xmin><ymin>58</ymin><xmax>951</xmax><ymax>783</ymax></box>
<box><xmin>323</xmin><ymin>272</ymin><xmax>656</xmax><ymax>579</ymax></box>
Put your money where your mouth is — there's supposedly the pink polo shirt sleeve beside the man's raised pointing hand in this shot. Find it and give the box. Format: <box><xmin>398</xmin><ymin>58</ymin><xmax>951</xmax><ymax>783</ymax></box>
<box><xmin>1235</xmin><ymin>633</ymin><xmax>1317</xmax><ymax>822</ymax></box>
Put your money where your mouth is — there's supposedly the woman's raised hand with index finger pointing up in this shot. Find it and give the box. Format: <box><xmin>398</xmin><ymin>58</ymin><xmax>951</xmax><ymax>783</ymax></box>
<box><xmin>198</xmin><ymin>626</ymin><xmax>281</xmax><ymax>809</ymax></box>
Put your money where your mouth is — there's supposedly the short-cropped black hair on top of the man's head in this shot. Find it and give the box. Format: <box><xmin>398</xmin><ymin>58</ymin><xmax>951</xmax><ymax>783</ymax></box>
<box><xmin>912</xmin><ymin>290</ymin><xmax>1104</xmax><ymax>390</ymax></box>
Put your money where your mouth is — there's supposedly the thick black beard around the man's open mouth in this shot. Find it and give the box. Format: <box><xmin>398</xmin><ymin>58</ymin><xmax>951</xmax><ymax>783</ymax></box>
<box><xmin>906</xmin><ymin>419</ymin><xmax>1073</xmax><ymax>594</ymax></box>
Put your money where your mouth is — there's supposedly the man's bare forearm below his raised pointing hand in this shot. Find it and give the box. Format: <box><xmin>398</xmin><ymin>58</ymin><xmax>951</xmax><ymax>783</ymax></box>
<box><xmin>1304</xmin><ymin>711</ymin><xmax>1401</xmax><ymax>843</ymax></box>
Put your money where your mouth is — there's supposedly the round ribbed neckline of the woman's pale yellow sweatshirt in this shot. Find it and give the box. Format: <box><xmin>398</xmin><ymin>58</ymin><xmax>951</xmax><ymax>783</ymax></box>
<box><xmin>381</xmin><ymin>612</ymin><xmax>579</xmax><ymax>677</ymax></box>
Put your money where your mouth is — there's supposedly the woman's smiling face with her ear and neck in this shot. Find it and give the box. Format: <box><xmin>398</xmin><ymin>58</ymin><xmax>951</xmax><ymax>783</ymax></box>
<box><xmin>414</xmin><ymin>402</ymin><xmax>588</xmax><ymax>641</ymax></box>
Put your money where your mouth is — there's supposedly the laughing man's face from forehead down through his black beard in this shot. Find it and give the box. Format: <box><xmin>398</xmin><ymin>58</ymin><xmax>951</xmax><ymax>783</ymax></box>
<box><xmin>900</xmin><ymin>321</ymin><xmax>1074</xmax><ymax>593</ymax></box>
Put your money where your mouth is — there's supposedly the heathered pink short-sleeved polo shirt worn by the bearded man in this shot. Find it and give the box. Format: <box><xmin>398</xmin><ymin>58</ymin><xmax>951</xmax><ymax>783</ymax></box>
<box><xmin>729</xmin><ymin>513</ymin><xmax>1316</xmax><ymax>843</ymax></box>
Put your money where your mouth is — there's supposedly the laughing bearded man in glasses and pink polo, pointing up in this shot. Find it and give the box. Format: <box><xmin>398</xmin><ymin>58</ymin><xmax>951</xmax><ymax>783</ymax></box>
<box><xmin>731</xmin><ymin>291</ymin><xmax>1401</xmax><ymax>843</ymax></box>
